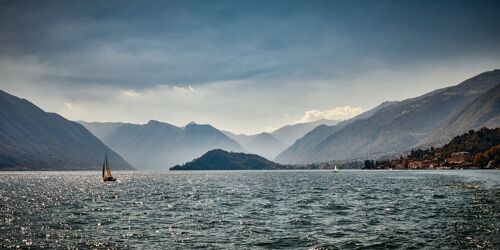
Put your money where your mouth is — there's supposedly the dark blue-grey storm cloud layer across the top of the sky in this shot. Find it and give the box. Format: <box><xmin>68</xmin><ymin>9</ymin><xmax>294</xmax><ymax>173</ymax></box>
<box><xmin>0</xmin><ymin>1</ymin><xmax>500</xmax><ymax>88</ymax></box>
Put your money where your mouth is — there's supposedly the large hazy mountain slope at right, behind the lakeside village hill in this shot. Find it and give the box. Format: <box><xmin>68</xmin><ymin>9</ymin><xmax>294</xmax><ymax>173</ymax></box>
<box><xmin>276</xmin><ymin>70</ymin><xmax>500</xmax><ymax>163</ymax></box>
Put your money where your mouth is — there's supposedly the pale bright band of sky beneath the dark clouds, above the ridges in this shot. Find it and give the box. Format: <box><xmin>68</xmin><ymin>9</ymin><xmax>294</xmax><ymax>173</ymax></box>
<box><xmin>0</xmin><ymin>51</ymin><xmax>500</xmax><ymax>134</ymax></box>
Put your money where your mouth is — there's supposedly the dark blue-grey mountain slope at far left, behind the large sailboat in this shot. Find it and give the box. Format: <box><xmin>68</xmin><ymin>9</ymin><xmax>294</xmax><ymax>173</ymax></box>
<box><xmin>0</xmin><ymin>90</ymin><xmax>133</xmax><ymax>170</ymax></box>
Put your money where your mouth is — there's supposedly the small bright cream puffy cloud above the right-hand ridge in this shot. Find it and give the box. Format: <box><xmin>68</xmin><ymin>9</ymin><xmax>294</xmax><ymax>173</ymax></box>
<box><xmin>296</xmin><ymin>106</ymin><xmax>363</xmax><ymax>123</ymax></box>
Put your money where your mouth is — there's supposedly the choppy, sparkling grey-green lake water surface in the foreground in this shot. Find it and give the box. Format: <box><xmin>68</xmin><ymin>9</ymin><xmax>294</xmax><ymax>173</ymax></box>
<box><xmin>0</xmin><ymin>171</ymin><xmax>500</xmax><ymax>249</ymax></box>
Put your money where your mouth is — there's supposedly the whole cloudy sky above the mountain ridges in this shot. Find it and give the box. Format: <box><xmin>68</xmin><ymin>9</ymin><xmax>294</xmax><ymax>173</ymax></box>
<box><xmin>0</xmin><ymin>0</ymin><xmax>500</xmax><ymax>134</ymax></box>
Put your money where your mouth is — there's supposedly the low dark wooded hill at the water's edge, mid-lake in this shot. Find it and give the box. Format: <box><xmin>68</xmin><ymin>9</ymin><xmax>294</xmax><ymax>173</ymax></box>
<box><xmin>171</xmin><ymin>149</ymin><xmax>280</xmax><ymax>170</ymax></box>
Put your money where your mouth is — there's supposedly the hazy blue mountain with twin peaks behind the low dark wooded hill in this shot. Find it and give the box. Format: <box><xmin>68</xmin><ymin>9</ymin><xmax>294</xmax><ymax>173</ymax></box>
<box><xmin>83</xmin><ymin>120</ymin><xmax>245</xmax><ymax>169</ymax></box>
